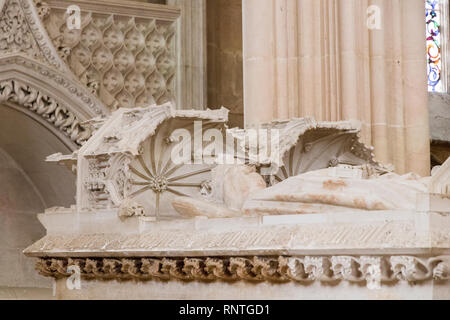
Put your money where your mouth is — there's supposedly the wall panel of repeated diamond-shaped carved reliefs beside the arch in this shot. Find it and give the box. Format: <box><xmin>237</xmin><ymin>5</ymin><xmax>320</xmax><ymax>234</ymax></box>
<box><xmin>43</xmin><ymin>0</ymin><xmax>180</xmax><ymax>110</ymax></box>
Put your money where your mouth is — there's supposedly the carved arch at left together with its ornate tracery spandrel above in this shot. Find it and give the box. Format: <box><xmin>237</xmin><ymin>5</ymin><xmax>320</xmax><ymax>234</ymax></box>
<box><xmin>0</xmin><ymin>0</ymin><xmax>110</xmax><ymax>146</ymax></box>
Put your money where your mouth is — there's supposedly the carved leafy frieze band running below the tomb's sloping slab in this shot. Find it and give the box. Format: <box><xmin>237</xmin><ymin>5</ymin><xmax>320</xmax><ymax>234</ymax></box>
<box><xmin>36</xmin><ymin>256</ymin><xmax>450</xmax><ymax>285</ymax></box>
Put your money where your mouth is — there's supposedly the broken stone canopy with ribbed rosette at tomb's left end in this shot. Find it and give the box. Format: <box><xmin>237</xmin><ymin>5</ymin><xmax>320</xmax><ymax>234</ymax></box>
<box><xmin>48</xmin><ymin>103</ymin><xmax>228</xmax><ymax>216</ymax></box>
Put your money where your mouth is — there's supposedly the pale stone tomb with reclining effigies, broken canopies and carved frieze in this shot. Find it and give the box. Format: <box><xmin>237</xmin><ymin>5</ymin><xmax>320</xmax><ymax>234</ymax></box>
<box><xmin>25</xmin><ymin>104</ymin><xmax>450</xmax><ymax>299</ymax></box>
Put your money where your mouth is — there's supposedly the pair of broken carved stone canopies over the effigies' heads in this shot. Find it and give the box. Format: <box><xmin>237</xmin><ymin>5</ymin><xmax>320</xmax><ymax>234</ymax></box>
<box><xmin>44</xmin><ymin>104</ymin><xmax>384</xmax><ymax>217</ymax></box>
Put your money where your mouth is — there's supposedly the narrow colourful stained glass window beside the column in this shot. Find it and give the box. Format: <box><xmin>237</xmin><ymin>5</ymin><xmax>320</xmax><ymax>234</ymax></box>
<box><xmin>425</xmin><ymin>0</ymin><xmax>446</xmax><ymax>92</ymax></box>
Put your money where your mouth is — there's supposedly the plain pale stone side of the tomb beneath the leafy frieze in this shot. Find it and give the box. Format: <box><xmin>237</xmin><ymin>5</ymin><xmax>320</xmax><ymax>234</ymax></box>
<box><xmin>56</xmin><ymin>279</ymin><xmax>450</xmax><ymax>300</ymax></box>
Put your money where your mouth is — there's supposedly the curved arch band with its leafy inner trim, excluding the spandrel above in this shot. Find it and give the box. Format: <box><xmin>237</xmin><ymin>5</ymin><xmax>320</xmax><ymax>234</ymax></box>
<box><xmin>0</xmin><ymin>55</ymin><xmax>109</xmax><ymax>146</ymax></box>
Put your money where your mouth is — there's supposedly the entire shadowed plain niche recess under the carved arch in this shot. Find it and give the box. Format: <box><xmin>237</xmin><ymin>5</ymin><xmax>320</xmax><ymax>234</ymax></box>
<box><xmin>0</xmin><ymin>104</ymin><xmax>75</xmax><ymax>299</ymax></box>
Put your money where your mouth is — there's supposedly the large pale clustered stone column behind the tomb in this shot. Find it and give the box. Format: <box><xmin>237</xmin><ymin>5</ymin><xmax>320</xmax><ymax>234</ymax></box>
<box><xmin>243</xmin><ymin>0</ymin><xmax>430</xmax><ymax>175</ymax></box>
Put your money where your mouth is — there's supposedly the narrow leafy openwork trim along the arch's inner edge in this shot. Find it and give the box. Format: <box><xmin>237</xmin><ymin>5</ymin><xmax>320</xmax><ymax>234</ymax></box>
<box><xmin>0</xmin><ymin>80</ymin><xmax>91</xmax><ymax>145</ymax></box>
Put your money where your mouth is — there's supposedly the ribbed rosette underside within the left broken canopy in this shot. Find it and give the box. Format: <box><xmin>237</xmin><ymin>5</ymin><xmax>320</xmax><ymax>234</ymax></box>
<box><xmin>124</xmin><ymin>120</ymin><xmax>218</xmax><ymax>217</ymax></box>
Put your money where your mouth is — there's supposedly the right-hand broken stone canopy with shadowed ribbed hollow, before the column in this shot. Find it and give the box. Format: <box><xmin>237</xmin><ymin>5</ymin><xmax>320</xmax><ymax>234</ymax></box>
<box><xmin>228</xmin><ymin>118</ymin><xmax>389</xmax><ymax>182</ymax></box>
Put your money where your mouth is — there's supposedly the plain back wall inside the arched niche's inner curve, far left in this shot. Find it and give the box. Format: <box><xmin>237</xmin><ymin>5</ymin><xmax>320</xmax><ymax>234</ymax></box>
<box><xmin>0</xmin><ymin>148</ymin><xmax>51</xmax><ymax>290</ymax></box>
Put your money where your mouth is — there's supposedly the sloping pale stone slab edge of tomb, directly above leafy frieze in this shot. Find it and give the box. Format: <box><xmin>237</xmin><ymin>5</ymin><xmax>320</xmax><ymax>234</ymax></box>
<box><xmin>25</xmin><ymin>209</ymin><xmax>450</xmax><ymax>257</ymax></box>
